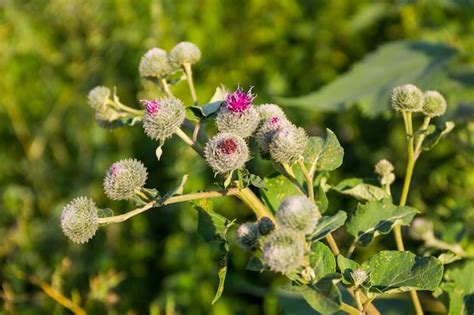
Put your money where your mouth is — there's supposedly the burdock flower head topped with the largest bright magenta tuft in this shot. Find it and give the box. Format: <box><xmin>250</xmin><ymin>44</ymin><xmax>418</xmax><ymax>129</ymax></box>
<box><xmin>216</xmin><ymin>87</ymin><xmax>260</xmax><ymax>138</ymax></box>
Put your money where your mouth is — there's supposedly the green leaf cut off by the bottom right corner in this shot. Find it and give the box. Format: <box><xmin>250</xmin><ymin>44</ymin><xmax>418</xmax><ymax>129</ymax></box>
<box><xmin>441</xmin><ymin>260</ymin><xmax>474</xmax><ymax>315</ymax></box>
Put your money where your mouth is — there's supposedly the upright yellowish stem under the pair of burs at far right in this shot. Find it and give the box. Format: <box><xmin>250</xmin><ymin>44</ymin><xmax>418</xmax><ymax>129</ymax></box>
<box><xmin>393</xmin><ymin>112</ymin><xmax>429</xmax><ymax>315</ymax></box>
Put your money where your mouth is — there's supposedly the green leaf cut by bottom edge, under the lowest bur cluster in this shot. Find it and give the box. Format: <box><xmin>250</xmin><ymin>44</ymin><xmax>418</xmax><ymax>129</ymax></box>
<box><xmin>292</xmin><ymin>277</ymin><xmax>342</xmax><ymax>314</ymax></box>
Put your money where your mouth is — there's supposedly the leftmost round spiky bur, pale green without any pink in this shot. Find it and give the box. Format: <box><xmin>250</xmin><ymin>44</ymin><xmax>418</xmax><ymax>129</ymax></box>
<box><xmin>61</xmin><ymin>197</ymin><xmax>99</xmax><ymax>244</ymax></box>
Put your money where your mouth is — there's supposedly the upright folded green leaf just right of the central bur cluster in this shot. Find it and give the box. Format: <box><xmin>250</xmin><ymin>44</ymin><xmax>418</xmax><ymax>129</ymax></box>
<box><xmin>303</xmin><ymin>129</ymin><xmax>344</xmax><ymax>175</ymax></box>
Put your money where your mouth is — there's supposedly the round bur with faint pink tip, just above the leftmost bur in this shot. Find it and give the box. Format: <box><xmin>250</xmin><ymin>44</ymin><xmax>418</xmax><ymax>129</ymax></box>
<box><xmin>104</xmin><ymin>159</ymin><xmax>148</xmax><ymax>200</ymax></box>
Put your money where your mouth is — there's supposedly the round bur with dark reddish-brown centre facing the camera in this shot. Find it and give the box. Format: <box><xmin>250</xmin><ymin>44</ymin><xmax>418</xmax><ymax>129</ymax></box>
<box><xmin>204</xmin><ymin>133</ymin><xmax>249</xmax><ymax>174</ymax></box>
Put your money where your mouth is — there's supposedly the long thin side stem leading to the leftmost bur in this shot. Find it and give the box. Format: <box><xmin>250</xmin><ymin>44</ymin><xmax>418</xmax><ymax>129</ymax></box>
<box><xmin>98</xmin><ymin>188</ymin><xmax>240</xmax><ymax>224</ymax></box>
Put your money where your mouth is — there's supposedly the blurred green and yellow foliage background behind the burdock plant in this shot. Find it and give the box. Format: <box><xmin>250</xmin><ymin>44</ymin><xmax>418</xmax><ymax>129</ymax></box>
<box><xmin>0</xmin><ymin>0</ymin><xmax>474</xmax><ymax>315</ymax></box>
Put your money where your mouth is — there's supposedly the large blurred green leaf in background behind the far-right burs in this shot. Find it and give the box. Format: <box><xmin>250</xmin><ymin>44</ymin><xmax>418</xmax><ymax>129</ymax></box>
<box><xmin>279</xmin><ymin>41</ymin><xmax>456</xmax><ymax>116</ymax></box>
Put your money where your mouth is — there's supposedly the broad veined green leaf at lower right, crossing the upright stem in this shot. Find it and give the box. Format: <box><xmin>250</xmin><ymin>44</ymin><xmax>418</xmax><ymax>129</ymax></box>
<box><xmin>361</xmin><ymin>251</ymin><xmax>443</xmax><ymax>293</ymax></box>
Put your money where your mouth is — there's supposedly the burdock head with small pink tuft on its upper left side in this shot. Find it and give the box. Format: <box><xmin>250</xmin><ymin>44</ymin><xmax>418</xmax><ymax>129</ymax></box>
<box><xmin>142</xmin><ymin>97</ymin><xmax>186</xmax><ymax>140</ymax></box>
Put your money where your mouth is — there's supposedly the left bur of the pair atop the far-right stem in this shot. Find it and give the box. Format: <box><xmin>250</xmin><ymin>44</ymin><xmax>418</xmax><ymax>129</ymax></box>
<box><xmin>390</xmin><ymin>84</ymin><xmax>424</xmax><ymax>112</ymax></box>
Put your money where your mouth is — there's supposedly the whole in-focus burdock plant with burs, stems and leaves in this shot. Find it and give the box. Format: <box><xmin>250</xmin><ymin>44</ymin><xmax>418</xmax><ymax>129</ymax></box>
<box><xmin>60</xmin><ymin>42</ymin><xmax>466</xmax><ymax>314</ymax></box>
